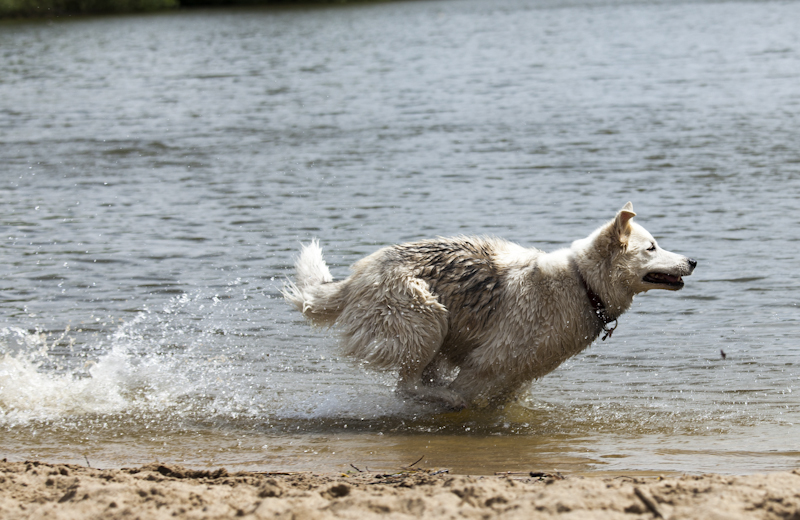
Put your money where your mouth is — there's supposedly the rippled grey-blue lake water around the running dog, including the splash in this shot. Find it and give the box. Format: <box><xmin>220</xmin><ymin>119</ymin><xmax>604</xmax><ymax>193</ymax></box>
<box><xmin>0</xmin><ymin>0</ymin><xmax>800</xmax><ymax>473</ymax></box>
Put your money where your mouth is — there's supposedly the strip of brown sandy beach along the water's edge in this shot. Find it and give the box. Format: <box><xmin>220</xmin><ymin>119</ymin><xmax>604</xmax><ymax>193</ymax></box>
<box><xmin>0</xmin><ymin>461</ymin><xmax>800</xmax><ymax>520</ymax></box>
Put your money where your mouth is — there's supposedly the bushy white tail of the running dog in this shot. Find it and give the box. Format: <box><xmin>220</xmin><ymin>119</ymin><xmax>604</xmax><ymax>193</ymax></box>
<box><xmin>281</xmin><ymin>239</ymin><xmax>344</xmax><ymax>325</ymax></box>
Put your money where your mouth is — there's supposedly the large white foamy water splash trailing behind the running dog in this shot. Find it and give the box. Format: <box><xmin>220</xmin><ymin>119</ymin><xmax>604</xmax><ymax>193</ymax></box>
<box><xmin>0</xmin><ymin>288</ymin><xmax>253</xmax><ymax>426</ymax></box>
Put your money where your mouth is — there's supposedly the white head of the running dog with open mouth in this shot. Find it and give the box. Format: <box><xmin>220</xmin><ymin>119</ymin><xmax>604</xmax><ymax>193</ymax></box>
<box><xmin>576</xmin><ymin>202</ymin><xmax>697</xmax><ymax>294</ymax></box>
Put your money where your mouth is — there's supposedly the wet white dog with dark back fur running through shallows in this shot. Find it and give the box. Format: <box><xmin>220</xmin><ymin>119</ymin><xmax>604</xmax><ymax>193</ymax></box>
<box><xmin>283</xmin><ymin>202</ymin><xmax>697</xmax><ymax>409</ymax></box>
